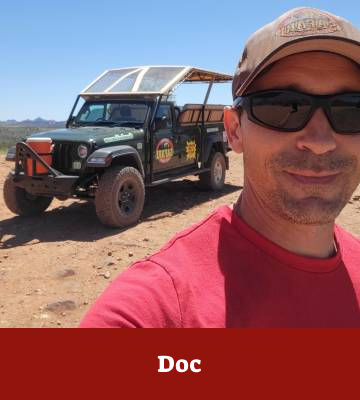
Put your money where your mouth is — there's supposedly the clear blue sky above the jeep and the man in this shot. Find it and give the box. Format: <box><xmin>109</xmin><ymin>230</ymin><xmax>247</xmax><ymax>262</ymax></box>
<box><xmin>0</xmin><ymin>0</ymin><xmax>360</xmax><ymax>120</ymax></box>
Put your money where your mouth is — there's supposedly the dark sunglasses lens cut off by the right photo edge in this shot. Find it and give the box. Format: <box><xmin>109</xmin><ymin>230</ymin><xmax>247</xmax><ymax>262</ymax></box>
<box><xmin>330</xmin><ymin>93</ymin><xmax>360</xmax><ymax>133</ymax></box>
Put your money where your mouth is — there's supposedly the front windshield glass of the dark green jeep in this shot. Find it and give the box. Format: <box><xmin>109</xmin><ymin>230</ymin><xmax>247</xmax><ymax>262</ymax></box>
<box><xmin>74</xmin><ymin>100</ymin><xmax>150</xmax><ymax>127</ymax></box>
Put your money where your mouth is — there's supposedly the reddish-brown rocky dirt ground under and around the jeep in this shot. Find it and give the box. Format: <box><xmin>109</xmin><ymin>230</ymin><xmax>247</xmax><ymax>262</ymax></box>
<box><xmin>0</xmin><ymin>153</ymin><xmax>360</xmax><ymax>327</ymax></box>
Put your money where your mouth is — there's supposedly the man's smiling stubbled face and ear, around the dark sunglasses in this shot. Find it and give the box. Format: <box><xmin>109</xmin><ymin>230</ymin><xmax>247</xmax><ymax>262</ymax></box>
<box><xmin>225</xmin><ymin>52</ymin><xmax>360</xmax><ymax>225</ymax></box>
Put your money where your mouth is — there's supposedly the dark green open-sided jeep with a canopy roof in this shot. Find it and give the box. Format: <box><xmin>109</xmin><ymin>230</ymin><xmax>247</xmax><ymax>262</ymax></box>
<box><xmin>4</xmin><ymin>66</ymin><xmax>232</xmax><ymax>227</ymax></box>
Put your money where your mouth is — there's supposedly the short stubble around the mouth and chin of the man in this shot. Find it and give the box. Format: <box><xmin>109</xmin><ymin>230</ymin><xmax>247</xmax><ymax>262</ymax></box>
<box><xmin>249</xmin><ymin>153</ymin><xmax>360</xmax><ymax>225</ymax></box>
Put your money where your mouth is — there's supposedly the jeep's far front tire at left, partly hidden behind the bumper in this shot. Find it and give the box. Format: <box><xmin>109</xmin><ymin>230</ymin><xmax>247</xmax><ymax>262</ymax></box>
<box><xmin>3</xmin><ymin>175</ymin><xmax>53</xmax><ymax>217</ymax></box>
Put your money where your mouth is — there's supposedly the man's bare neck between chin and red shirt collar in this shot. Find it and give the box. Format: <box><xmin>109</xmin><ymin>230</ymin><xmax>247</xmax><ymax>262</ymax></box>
<box><xmin>234</xmin><ymin>189</ymin><xmax>336</xmax><ymax>258</ymax></box>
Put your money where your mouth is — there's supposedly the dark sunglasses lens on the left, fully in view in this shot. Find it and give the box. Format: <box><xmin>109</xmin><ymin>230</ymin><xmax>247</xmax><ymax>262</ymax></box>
<box><xmin>251</xmin><ymin>91</ymin><xmax>311</xmax><ymax>130</ymax></box>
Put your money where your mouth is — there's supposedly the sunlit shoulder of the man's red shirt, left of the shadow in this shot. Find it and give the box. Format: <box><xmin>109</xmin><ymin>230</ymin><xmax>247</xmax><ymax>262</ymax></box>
<box><xmin>81</xmin><ymin>207</ymin><xmax>232</xmax><ymax>328</ymax></box>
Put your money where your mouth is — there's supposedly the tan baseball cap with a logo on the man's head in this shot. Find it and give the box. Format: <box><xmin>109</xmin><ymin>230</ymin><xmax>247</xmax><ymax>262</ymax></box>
<box><xmin>232</xmin><ymin>7</ymin><xmax>360</xmax><ymax>98</ymax></box>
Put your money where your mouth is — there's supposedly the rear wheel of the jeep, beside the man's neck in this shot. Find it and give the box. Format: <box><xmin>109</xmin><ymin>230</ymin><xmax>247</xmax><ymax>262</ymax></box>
<box><xmin>199</xmin><ymin>151</ymin><xmax>226</xmax><ymax>191</ymax></box>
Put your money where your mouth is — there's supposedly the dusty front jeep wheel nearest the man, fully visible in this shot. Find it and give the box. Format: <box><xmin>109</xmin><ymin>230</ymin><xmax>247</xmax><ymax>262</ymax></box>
<box><xmin>95</xmin><ymin>166</ymin><xmax>145</xmax><ymax>228</ymax></box>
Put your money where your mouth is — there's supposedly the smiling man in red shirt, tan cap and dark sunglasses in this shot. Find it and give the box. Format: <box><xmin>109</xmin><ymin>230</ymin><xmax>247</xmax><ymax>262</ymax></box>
<box><xmin>82</xmin><ymin>8</ymin><xmax>360</xmax><ymax>327</ymax></box>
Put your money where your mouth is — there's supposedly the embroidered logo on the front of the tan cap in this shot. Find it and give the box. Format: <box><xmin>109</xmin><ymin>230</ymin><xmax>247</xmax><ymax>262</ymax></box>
<box><xmin>276</xmin><ymin>9</ymin><xmax>341</xmax><ymax>37</ymax></box>
